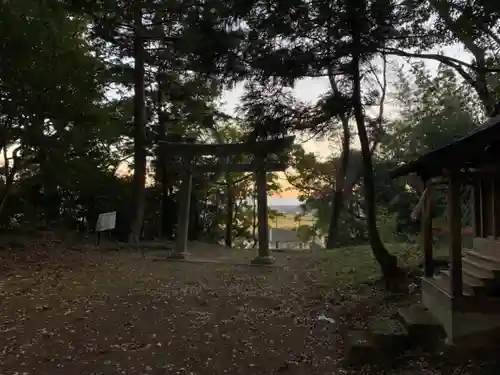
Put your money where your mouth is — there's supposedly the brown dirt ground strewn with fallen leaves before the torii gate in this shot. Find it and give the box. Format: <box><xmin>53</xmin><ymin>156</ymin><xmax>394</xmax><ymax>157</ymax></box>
<box><xmin>0</xmin><ymin>239</ymin><xmax>498</xmax><ymax>375</ymax></box>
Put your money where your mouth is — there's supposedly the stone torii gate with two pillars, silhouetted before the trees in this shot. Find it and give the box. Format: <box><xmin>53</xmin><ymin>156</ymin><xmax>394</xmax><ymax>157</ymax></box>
<box><xmin>162</xmin><ymin>136</ymin><xmax>295</xmax><ymax>264</ymax></box>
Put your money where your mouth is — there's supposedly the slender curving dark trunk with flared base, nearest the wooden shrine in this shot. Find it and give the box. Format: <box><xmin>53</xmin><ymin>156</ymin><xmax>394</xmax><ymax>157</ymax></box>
<box><xmin>352</xmin><ymin>51</ymin><xmax>401</xmax><ymax>286</ymax></box>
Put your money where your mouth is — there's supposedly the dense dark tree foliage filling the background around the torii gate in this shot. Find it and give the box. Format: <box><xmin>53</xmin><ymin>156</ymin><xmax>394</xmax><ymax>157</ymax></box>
<box><xmin>0</xmin><ymin>0</ymin><xmax>500</xmax><ymax>271</ymax></box>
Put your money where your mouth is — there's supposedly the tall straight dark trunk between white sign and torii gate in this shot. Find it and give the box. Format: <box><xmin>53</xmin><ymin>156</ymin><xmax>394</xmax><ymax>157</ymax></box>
<box><xmin>129</xmin><ymin>0</ymin><xmax>146</xmax><ymax>243</ymax></box>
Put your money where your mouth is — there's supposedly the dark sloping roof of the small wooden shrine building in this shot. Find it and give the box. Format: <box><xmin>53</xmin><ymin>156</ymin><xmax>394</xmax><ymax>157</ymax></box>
<box><xmin>389</xmin><ymin>115</ymin><xmax>500</xmax><ymax>179</ymax></box>
